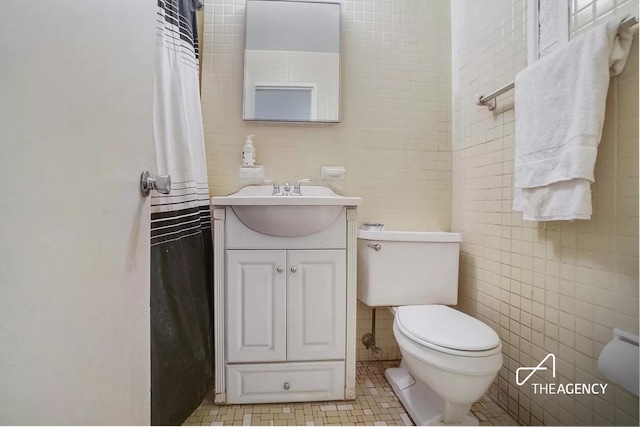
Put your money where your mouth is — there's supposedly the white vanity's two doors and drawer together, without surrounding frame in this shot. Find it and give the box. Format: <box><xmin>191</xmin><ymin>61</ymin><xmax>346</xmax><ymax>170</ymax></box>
<box><xmin>225</xmin><ymin>249</ymin><xmax>347</xmax><ymax>403</ymax></box>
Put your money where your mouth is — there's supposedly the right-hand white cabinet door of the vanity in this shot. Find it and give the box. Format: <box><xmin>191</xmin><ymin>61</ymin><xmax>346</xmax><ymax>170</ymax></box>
<box><xmin>287</xmin><ymin>250</ymin><xmax>347</xmax><ymax>361</ymax></box>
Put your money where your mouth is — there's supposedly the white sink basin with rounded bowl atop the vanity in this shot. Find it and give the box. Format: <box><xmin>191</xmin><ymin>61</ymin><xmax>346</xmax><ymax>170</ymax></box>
<box><xmin>211</xmin><ymin>185</ymin><xmax>362</xmax><ymax>237</ymax></box>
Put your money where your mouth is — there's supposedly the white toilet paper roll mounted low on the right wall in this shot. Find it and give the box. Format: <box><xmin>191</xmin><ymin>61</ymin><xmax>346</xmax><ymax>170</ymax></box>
<box><xmin>598</xmin><ymin>339</ymin><xmax>640</xmax><ymax>396</ymax></box>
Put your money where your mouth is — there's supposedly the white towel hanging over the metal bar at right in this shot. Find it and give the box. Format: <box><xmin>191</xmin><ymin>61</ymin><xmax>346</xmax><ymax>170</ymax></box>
<box><xmin>513</xmin><ymin>18</ymin><xmax>632</xmax><ymax>221</ymax></box>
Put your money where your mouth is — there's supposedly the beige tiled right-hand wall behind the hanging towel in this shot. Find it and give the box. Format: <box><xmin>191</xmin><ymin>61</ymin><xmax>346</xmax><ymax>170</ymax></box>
<box><xmin>452</xmin><ymin>0</ymin><xmax>638</xmax><ymax>425</ymax></box>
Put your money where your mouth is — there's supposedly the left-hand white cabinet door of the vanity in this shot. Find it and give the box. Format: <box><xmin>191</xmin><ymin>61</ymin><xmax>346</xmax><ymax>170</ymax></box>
<box><xmin>225</xmin><ymin>251</ymin><xmax>287</xmax><ymax>362</ymax></box>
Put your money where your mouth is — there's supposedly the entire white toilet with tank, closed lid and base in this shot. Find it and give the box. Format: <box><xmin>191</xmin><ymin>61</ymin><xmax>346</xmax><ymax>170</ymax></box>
<box><xmin>358</xmin><ymin>230</ymin><xmax>502</xmax><ymax>425</ymax></box>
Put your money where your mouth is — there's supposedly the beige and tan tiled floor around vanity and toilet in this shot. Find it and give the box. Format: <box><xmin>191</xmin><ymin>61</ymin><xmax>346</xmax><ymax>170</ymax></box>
<box><xmin>184</xmin><ymin>361</ymin><xmax>518</xmax><ymax>426</ymax></box>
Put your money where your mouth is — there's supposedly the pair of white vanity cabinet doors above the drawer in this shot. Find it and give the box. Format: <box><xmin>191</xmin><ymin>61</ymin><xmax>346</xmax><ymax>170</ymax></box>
<box><xmin>225</xmin><ymin>249</ymin><xmax>347</xmax><ymax>363</ymax></box>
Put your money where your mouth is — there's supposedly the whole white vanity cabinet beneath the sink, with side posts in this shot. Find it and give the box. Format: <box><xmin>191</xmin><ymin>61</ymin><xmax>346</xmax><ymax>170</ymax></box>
<box><xmin>213</xmin><ymin>194</ymin><xmax>356</xmax><ymax>404</ymax></box>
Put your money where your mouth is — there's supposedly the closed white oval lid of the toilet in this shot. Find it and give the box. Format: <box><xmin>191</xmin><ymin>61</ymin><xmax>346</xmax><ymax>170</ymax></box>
<box><xmin>396</xmin><ymin>305</ymin><xmax>500</xmax><ymax>351</ymax></box>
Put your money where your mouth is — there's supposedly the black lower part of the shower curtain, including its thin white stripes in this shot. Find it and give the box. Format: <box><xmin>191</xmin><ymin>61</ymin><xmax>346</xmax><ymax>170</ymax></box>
<box><xmin>151</xmin><ymin>208</ymin><xmax>213</xmax><ymax>425</ymax></box>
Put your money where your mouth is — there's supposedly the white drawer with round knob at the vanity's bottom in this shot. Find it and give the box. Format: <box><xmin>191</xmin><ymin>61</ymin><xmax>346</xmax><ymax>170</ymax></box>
<box><xmin>227</xmin><ymin>362</ymin><xmax>345</xmax><ymax>403</ymax></box>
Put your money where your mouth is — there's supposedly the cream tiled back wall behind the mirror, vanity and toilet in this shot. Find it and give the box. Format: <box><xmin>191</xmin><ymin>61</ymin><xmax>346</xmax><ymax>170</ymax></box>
<box><xmin>202</xmin><ymin>0</ymin><xmax>451</xmax><ymax>359</ymax></box>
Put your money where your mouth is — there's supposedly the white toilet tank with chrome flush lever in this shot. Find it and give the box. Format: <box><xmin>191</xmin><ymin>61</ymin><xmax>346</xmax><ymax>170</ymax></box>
<box><xmin>358</xmin><ymin>230</ymin><xmax>462</xmax><ymax>307</ymax></box>
